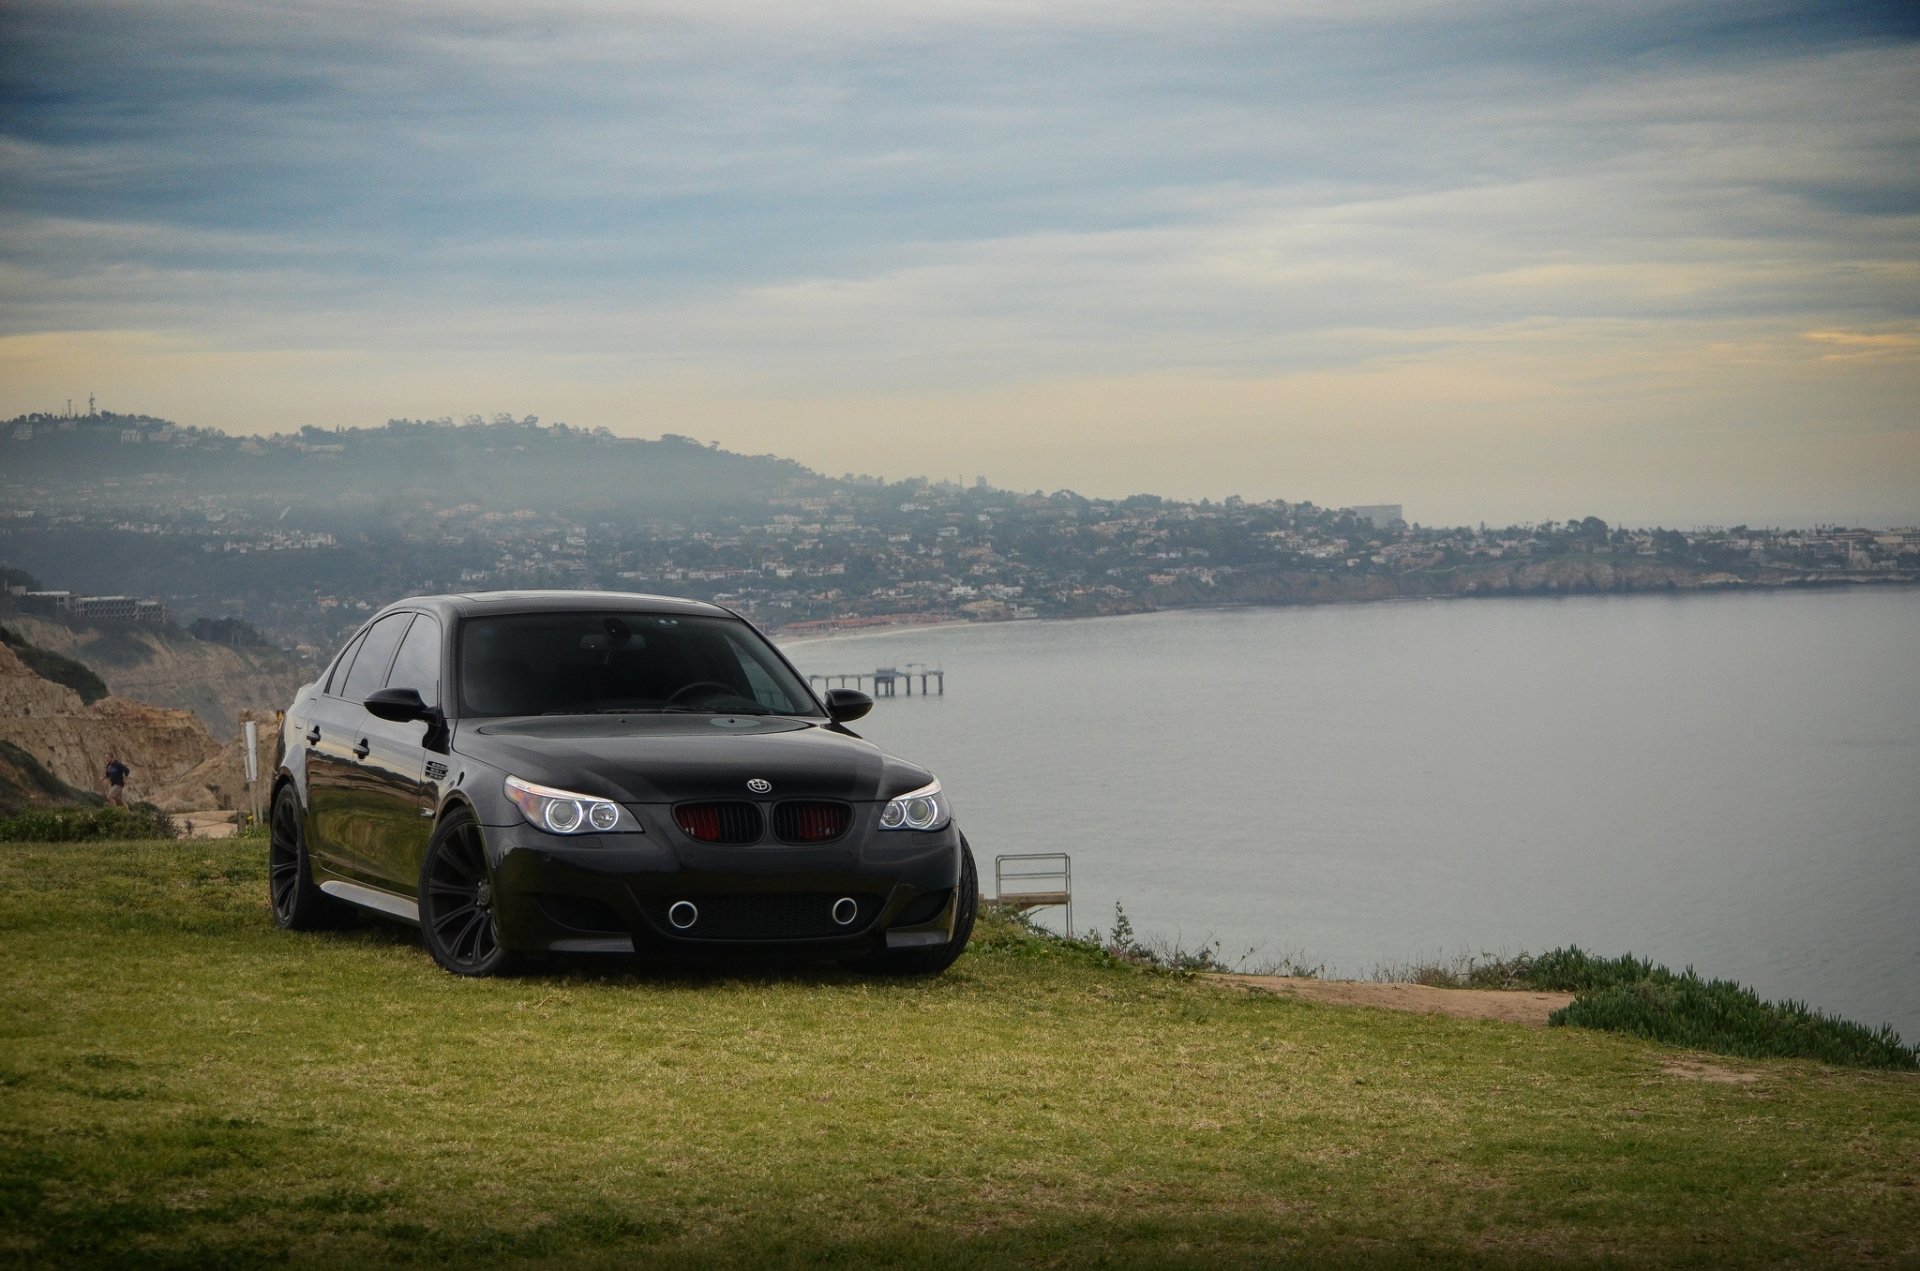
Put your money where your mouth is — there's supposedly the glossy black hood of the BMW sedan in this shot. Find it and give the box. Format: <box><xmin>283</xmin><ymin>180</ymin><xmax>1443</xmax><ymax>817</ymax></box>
<box><xmin>453</xmin><ymin>714</ymin><xmax>933</xmax><ymax>803</ymax></box>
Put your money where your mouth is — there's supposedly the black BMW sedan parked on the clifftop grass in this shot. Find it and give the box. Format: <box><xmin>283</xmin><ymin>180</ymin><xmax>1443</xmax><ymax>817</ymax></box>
<box><xmin>269</xmin><ymin>591</ymin><xmax>979</xmax><ymax>975</ymax></box>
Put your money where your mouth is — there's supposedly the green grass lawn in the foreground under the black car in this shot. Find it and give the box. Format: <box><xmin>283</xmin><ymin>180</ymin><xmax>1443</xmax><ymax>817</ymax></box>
<box><xmin>0</xmin><ymin>841</ymin><xmax>1920</xmax><ymax>1267</ymax></box>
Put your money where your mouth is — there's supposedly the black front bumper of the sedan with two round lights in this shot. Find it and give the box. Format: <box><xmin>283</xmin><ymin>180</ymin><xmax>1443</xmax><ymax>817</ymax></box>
<box><xmin>484</xmin><ymin>826</ymin><xmax>960</xmax><ymax>956</ymax></box>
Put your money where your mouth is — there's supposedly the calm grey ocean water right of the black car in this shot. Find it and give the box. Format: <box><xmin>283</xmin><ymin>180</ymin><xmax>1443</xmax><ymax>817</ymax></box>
<box><xmin>785</xmin><ymin>588</ymin><xmax>1920</xmax><ymax>1041</ymax></box>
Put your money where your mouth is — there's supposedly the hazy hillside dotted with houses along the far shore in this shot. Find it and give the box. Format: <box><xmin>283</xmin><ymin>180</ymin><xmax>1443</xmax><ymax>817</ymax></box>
<box><xmin>0</xmin><ymin>403</ymin><xmax>1920</xmax><ymax>656</ymax></box>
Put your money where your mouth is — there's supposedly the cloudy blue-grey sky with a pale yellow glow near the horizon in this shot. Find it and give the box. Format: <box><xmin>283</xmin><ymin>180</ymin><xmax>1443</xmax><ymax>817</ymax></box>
<box><xmin>0</xmin><ymin>0</ymin><xmax>1920</xmax><ymax>528</ymax></box>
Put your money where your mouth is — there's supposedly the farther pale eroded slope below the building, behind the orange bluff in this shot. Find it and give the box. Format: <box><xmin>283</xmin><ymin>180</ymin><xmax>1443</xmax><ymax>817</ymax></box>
<box><xmin>6</xmin><ymin>614</ymin><xmax>311</xmax><ymax>741</ymax></box>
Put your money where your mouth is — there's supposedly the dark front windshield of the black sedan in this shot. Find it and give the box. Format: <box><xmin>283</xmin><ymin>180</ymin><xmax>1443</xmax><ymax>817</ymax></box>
<box><xmin>459</xmin><ymin>612</ymin><xmax>820</xmax><ymax>716</ymax></box>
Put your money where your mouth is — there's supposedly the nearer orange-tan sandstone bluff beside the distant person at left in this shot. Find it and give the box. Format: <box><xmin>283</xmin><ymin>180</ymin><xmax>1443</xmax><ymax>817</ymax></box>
<box><xmin>0</xmin><ymin>645</ymin><xmax>221</xmax><ymax>812</ymax></box>
